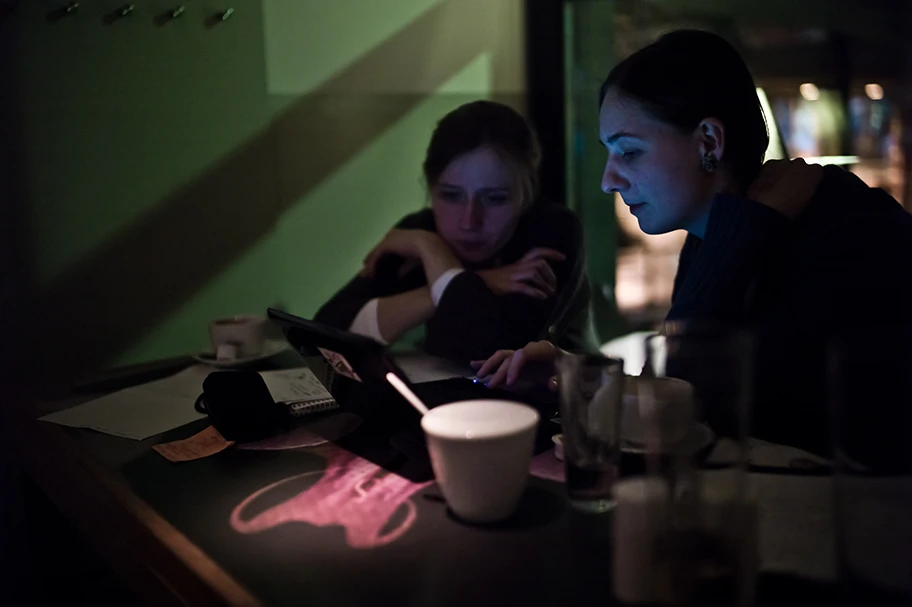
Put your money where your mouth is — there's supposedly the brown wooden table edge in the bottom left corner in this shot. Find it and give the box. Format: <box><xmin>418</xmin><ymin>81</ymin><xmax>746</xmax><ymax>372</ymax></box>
<box><xmin>13</xmin><ymin>408</ymin><xmax>262</xmax><ymax>607</ymax></box>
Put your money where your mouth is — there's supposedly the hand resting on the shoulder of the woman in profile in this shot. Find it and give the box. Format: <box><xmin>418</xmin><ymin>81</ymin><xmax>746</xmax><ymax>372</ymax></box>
<box><xmin>747</xmin><ymin>158</ymin><xmax>823</xmax><ymax>219</ymax></box>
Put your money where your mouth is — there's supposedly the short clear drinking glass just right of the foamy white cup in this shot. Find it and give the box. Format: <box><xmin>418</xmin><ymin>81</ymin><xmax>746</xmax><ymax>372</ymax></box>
<box><xmin>557</xmin><ymin>354</ymin><xmax>624</xmax><ymax>512</ymax></box>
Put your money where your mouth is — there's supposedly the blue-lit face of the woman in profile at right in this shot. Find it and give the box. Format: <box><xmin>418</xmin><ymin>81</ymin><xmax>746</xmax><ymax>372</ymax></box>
<box><xmin>599</xmin><ymin>90</ymin><xmax>713</xmax><ymax>236</ymax></box>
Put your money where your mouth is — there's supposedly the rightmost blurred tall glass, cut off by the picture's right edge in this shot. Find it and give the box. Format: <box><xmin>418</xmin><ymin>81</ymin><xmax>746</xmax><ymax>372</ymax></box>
<box><xmin>829</xmin><ymin>327</ymin><xmax>912</xmax><ymax>605</ymax></box>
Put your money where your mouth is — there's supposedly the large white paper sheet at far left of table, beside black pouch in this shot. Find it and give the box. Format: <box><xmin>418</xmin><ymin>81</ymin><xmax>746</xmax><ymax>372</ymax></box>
<box><xmin>39</xmin><ymin>365</ymin><xmax>213</xmax><ymax>440</ymax></box>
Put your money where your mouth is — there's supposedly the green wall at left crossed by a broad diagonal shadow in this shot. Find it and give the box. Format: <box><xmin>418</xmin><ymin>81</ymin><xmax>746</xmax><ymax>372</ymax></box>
<box><xmin>14</xmin><ymin>0</ymin><xmax>524</xmax><ymax>384</ymax></box>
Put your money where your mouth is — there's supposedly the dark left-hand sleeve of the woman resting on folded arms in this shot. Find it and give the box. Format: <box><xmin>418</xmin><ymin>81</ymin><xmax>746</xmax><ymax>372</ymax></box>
<box><xmin>314</xmin><ymin>210</ymin><xmax>433</xmax><ymax>330</ymax></box>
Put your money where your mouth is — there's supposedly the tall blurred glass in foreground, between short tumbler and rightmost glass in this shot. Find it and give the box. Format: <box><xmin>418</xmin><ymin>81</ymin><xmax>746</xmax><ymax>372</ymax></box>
<box><xmin>638</xmin><ymin>322</ymin><xmax>759</xmax><ymax>607</ymax></box>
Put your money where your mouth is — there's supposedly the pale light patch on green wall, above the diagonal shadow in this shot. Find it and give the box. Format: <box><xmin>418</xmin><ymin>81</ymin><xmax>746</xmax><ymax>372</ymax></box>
<box><xmin>263</xmin><ymin>0</ymin><xmax>441</xmax><ymax>95</ymax></box>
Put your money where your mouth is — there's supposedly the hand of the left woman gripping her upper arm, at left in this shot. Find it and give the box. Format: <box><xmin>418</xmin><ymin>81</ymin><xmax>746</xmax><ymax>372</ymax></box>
<box><xmin>358</xmin><ymin>228</ymin><xmax>461</xmax><ymax>284</ymax></box>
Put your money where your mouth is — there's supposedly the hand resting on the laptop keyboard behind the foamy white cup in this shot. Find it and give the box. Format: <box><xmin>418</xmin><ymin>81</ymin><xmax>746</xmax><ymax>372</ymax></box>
<box><xmin>469</xmin><ymin>341</ymin><xmax>562</xmax><ymax>391</ymax></box>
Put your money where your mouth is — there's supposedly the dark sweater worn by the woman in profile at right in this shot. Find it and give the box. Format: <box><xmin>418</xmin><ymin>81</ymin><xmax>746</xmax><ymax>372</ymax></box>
<box><xmin>668</xmin><ymin>166</ymin><xmax>912</xmax><ymax>467</ymax></box>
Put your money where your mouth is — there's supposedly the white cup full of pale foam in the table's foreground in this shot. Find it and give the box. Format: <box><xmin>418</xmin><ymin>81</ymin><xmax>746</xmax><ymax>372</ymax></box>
<box><xmin>421</xmin><ymin>400</ymin><xmax>538</xmax><ymax>523</ymax></box>
